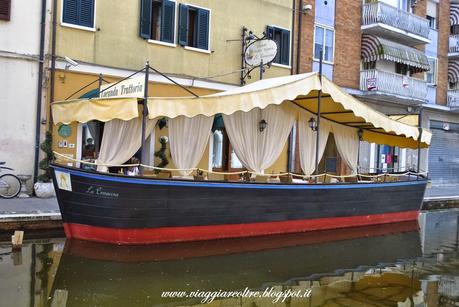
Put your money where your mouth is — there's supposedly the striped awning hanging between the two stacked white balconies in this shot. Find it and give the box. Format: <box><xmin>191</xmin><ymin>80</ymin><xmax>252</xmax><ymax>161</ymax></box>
<box><xmin>362</xmin><ymin>35</ymin><xmax>430</xmax><ymax>72</ymax></box>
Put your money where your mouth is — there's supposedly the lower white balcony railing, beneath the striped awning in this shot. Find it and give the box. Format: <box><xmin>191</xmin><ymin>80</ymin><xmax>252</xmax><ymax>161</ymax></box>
<box><xmin>360</xmin><ymin>69</ymin><xmax>427</xmax><ymax>100</ymax></box>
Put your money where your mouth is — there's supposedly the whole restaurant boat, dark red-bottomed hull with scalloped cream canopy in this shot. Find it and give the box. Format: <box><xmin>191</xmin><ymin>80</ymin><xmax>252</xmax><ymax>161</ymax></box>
<box><xmin>52</xmin><ymin>73</ymin><xmax>431</xmax><ymax>244</ymax></box>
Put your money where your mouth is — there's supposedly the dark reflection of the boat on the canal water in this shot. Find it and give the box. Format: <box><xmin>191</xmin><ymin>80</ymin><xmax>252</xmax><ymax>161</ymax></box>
<box><xmin>49</xmin><ymin>222</ymin><xmax>421</xmax><ymax>306</ymax></box>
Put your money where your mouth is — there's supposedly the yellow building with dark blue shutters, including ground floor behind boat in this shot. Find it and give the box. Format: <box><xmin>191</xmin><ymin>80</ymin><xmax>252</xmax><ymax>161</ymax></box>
<box><xmin>50</xmin><ymin>0</ymin><xmax>293</xmax><ymax>177</ymax></box>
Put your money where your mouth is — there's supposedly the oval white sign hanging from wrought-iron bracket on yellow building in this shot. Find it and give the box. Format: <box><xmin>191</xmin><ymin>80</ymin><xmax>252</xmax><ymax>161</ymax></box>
<box><xmin>244</xmin><ymin>39</ymin><xmax>277</xmax><ymax>66</ymax></box>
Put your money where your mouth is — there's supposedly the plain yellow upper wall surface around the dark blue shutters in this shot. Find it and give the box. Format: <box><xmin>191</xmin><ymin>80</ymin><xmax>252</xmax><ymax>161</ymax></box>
<box><xmin>57</xmin><ymin>0</ymin><xmax>292</xmax><ymax>84</ymax></box>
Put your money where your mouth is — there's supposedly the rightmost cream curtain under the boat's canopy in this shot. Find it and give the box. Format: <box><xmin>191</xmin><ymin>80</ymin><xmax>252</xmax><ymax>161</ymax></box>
<box><xmin>332</xmin><ymin>123</ymin><xmax>360</xmax><ymax>174</ymax></box>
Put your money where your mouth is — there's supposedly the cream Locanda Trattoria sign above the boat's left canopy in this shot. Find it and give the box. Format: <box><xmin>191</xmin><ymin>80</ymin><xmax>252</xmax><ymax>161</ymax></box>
<box><xmin>99</xmin><ymin>76</ymin><xmax>145</xmax><ymax>98</ymax></box>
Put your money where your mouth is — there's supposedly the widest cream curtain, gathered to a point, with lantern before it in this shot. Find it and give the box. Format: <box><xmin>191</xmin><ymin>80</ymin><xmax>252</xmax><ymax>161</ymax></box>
<box><xmin>223</xmin><ymin>105</ymin><xmax>296</xmax><ymax>173</ymax></box>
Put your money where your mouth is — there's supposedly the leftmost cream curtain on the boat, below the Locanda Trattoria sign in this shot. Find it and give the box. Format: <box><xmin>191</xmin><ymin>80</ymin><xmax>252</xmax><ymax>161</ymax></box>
<box><xmin>97</xmin><ymin>118</ymin><xmax>157</xmax><ymax>172</ymax></box>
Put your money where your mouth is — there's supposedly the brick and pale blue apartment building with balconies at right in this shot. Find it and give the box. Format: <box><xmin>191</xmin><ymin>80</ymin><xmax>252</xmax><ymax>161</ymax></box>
<box><xmin>293</xmin><ymin>0</ymin><xmax>459</xmax><ymax>184</ymax></box>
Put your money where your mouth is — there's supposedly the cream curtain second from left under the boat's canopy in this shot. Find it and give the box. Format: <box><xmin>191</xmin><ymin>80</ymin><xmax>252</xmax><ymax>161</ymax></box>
<box><xmin>169</xmin><ymin>115</ymin><xmax>214</xmax><ymax>176</ymax></box>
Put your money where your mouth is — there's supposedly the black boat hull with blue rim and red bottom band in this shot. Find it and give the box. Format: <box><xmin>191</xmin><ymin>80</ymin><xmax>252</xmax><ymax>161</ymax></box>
<box><xmin>53</xmin><ymin>166</ymin><xmax>426</xmax><ymax>244</ymax></box>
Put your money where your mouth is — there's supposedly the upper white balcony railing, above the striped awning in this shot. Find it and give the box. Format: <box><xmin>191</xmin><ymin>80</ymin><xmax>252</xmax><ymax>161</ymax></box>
<box><xmin>362</xmin><ymin>2</ymin><xmax>430</xmax><ymax>39</ymax></box>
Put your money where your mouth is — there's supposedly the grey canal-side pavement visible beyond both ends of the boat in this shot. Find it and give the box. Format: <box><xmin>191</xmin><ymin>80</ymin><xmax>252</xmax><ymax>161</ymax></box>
<box><xmin>0</xmin><ymin>185</ymin><xmax>459</xmax><ymax>230</ymax></box>
